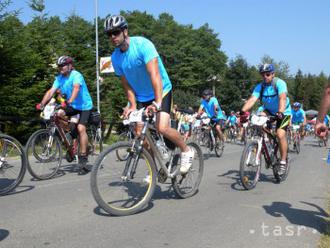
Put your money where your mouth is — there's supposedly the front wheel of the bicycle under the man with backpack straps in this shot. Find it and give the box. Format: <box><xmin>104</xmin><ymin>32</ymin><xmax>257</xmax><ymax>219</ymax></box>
<box><xmin>239</xmin><ymin>140</ymin><xmax>262</xmax><ymax>190</ymax></box>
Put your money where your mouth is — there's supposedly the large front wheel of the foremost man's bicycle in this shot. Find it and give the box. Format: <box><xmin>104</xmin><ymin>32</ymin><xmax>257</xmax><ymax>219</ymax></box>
<box><xmin>91</xmin><ymin>142</ymin><xmax>156</xmax><ymax>216</ymax></box>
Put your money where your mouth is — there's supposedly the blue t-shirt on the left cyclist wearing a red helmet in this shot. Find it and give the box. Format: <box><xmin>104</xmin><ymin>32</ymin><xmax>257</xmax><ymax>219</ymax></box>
<box><xmin>53</xmin><ymin>70</ymin><xmax>93</xmax><ymax>110</ymax></box>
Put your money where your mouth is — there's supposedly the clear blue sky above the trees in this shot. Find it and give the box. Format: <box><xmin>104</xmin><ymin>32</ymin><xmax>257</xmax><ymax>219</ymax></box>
<box><xmin>9</xmin><ymin>0</ymin><xmax>330</xmax><ymax>75</ymax></box>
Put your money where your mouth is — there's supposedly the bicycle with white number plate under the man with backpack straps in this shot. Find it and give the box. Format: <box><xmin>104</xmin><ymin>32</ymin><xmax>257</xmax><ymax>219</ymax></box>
<box><xmin>240</xmin><ymin>115</ymin><xmax>290</xmax><ymax>190</ymax></box>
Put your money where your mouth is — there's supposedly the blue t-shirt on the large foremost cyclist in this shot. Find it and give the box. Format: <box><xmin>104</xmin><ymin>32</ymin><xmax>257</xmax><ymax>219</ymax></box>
<box><xmin>111</xmin><ymin>37</ymin><xmax>172</xmax><ymax>102</ymax></box>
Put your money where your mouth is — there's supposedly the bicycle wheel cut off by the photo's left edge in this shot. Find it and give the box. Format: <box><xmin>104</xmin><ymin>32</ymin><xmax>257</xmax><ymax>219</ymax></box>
<box><xmin>0</xmin><ymin>133</ymin><xmax>27</xmax><ymax>195</ymax></box>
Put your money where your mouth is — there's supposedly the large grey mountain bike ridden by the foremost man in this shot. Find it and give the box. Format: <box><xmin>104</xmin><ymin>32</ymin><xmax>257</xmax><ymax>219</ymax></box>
<box><xmin>91</xmin><ymin>109</ymin><xmax>204</xmax><ymax>216</ymax></box>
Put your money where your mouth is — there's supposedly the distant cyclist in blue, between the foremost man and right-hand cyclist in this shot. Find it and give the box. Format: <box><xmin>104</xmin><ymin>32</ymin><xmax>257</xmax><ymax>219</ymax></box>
<box><xmin>198</xmin><ymin>89</ymin><xmax>224</xmax><ymax>141</ymax></box>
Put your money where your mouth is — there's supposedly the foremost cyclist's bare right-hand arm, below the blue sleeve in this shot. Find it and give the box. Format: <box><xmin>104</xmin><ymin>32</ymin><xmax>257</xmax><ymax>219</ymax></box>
<box><xmin>146</xmin><ymin>58</ymin><xmax>163</xmax><ymax>106</ymax></box>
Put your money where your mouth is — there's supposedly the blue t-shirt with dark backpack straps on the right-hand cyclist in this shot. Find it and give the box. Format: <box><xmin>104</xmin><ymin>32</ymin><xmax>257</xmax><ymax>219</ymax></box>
<box><xmin>252</xmin><ymin>78</ymin><xmax>291</xmax><ymax>115</ymax></box>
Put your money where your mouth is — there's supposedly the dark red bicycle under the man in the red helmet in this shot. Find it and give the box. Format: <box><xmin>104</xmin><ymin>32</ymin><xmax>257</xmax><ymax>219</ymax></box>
<box><xmin>25</xmin><ymin>101</ymin><xmax>103</xmax><ymax>180</ymax></box>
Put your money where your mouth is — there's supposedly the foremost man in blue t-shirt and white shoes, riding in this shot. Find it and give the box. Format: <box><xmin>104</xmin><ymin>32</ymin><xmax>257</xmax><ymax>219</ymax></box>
<box><xmin>104</xmin><ymin>15</ymin><xmax>194</xmax><ymax>174</ymax></box>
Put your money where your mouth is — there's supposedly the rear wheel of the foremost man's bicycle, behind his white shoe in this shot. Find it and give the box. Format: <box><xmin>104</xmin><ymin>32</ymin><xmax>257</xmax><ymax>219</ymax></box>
<box><xmin>172</xmin><ymin>142</ymin><xmax>204</xmax><ymax>199</ymax></box>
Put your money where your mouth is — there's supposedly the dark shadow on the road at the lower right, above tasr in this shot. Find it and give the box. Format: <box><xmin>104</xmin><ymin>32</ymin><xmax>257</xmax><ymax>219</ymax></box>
<box><xmin>263</xmin><ymin>201</ymin><xmax>330</xmax><ymax>234</ymax></box>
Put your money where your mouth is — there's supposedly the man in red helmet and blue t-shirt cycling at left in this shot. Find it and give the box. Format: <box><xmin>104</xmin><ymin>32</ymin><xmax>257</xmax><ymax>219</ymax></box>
<box><xmin>36</xmin><ymin>55</ymin><xmax>93</xmax><ymax>174</ymax></box>
